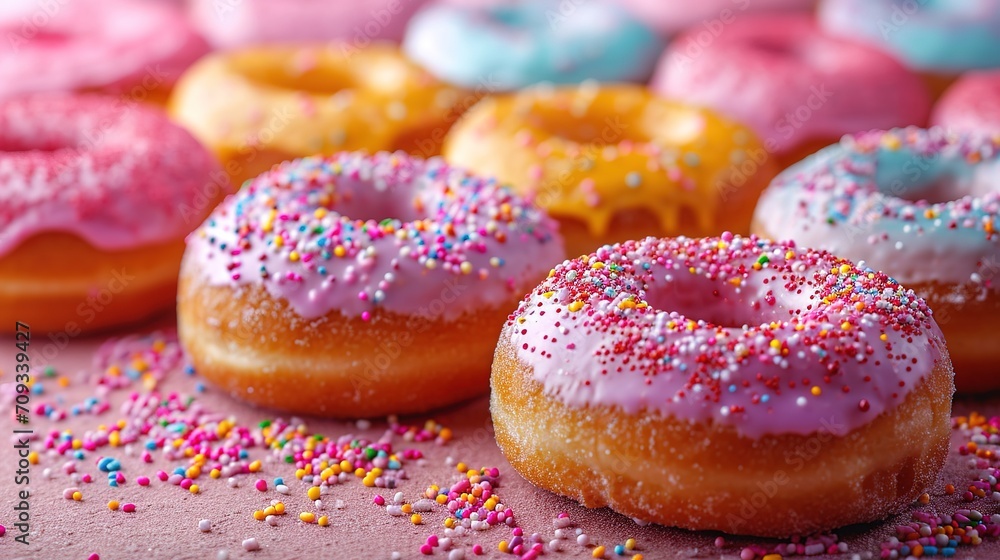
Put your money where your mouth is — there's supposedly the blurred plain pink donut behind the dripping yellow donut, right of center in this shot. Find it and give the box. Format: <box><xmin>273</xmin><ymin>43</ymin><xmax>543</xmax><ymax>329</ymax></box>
<box><xmin>651</xmin><ymin>15</ymin><xmax>931</xmax><ymax>167</ymax></box>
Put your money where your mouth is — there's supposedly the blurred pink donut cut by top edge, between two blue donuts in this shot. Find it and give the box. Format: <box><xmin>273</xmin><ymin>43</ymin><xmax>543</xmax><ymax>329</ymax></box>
<box><xmin>616</xmin><ymin>0</ymin><xmax>816</xmax><ymax>38</ymax></box>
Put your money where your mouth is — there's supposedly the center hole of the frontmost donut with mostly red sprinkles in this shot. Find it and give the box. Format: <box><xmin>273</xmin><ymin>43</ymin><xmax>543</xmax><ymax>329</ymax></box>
<box><xmin>646</xmin><ymin>270</ymin><xmax>791</xmax><ymax>329</ymax></box>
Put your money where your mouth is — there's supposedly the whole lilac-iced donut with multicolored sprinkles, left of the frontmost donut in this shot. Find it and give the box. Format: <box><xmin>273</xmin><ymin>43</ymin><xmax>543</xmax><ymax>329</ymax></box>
<box><xmin>177</xmin><ymin>152</ymin><xmax>564</xmax><ymax>417</ymax></box>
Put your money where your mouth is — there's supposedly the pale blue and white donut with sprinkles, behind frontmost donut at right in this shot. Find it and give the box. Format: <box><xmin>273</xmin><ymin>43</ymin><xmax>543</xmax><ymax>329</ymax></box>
<box><xmin>752</xmin><ymin>128</ymin><xmax>1000</xmax><ymax>392</ymax></box>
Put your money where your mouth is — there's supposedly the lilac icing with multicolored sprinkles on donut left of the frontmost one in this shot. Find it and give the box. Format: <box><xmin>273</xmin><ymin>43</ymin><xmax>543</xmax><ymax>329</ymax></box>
<box><xmin>185</xmin><ymin>152</ymin><xmax>563</xmax><ymax>320</ymax></box>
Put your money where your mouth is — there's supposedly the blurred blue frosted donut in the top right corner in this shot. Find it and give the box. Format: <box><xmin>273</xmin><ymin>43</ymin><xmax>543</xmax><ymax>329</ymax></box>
<box><xmin>819</xmin><ymin>0</ymin><xmax>1000</xmax><ymax>74</ymax></box>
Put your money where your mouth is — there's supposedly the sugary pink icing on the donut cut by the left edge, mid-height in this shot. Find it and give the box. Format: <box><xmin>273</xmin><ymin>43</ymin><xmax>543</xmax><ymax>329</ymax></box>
<box><xmin>0</xmin><ymin>94</ymin><xmax>229</xmax><ymax>255</ymax></box>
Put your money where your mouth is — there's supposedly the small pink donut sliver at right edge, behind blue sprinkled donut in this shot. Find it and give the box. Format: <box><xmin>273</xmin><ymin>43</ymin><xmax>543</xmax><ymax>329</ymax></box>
<box><xmin>931</xmin><ymin>70</ymin><xmax>1000</xmax><ymax>135</ymax></box>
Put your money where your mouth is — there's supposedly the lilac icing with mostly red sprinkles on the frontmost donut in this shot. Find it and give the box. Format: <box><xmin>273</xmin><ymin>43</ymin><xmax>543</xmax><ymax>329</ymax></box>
<box><xmin>503</xmin><ymin>234</ymin><xmax>944</xmax><ymax>438</ymax></box>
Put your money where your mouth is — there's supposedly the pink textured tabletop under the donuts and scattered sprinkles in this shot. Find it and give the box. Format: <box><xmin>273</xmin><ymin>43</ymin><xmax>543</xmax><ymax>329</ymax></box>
<box><xmin>0</xmin><ymin>317</ymin><xmax>1000</xmax><ymax>560</ymax></box>
